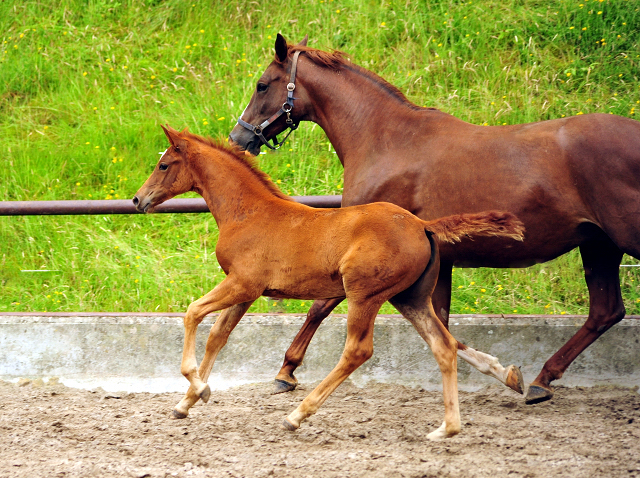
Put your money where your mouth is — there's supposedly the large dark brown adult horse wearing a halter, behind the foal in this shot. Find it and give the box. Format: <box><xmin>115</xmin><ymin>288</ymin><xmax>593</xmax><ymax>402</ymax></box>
<box><xmin>230</xmin><ymin>36</ymin><xmax>640</xmax><ymax>403</ymax></box>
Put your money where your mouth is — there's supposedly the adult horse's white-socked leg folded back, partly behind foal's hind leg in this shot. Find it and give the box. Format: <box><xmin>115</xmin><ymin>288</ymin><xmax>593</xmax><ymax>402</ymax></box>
<box><xmin>432</xmin><ymin>262</ymin><xmax>524</xmax><ymax>394</ymax></box>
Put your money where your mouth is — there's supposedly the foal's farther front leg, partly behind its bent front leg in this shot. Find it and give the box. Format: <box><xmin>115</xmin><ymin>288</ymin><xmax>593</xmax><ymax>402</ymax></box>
<box><xmin>173</xmin><ymin>301</ymin><xmax>253</xmax><ymax>418</ymax></box>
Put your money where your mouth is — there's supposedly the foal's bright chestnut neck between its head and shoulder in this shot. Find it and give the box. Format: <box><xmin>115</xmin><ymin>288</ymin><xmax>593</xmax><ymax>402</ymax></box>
<box><xmin>193</xmin><ymin>152</ymin><xmax>277</xmax><ymax>232</ymax></box>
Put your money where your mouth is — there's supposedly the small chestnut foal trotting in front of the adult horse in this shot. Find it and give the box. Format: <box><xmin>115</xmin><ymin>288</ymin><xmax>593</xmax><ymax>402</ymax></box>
<box><xmin>133</xmin><ymin>127</ymin><xmax>523</xmax><ymax>439</ymax></box>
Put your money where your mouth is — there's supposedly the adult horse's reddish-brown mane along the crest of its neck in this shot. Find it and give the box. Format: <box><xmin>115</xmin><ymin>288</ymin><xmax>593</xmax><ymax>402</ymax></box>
<box><xmin>284</xmin><ymin>44</ymin><xmax>424</xmax><ymax>110</ymax></box>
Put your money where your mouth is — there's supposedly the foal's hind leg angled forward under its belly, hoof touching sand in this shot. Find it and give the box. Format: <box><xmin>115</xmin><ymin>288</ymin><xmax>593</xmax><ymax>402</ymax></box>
<box><xmin>282</xmin><ymin>299</ymin><xmax>383</xmax><ymax>430</ymax></box>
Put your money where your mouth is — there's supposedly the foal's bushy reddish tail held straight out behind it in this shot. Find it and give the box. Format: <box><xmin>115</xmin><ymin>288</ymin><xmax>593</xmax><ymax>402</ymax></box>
<box><xmin>422</xmin><ymin>211</ymin><xmax>524</xmax><ymax>243</ymax></box>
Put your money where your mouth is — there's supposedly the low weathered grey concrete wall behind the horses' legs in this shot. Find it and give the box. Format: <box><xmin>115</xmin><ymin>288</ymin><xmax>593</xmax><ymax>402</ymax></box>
<box><xmin>0</xmin><ymin>314</ymin><xmax>640</xmax><ymax>392</ymax></box>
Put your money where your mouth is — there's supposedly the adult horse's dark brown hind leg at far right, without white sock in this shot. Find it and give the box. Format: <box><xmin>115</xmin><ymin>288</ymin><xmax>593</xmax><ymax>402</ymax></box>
<box><xmin>526</xmin><ymin>240</ymin><xmax>625</xmax><ymax>404</ymax></box>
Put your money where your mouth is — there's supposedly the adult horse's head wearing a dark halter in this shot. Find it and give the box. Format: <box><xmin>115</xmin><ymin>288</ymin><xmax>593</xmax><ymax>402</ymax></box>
<box><xmin>229</xmin><ymin>33</ymin><xmax>307</xmax><ymax>155</ymax></box>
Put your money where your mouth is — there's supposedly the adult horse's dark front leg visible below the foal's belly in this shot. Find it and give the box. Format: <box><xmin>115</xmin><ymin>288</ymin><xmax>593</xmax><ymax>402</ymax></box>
<box><xmin>273</xmin><ymin>297</ymin><xmax>344</xmax><ymax>394</ymax></box>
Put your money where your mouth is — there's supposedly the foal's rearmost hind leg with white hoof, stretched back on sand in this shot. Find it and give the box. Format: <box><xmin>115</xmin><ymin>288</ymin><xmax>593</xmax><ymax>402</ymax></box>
<box><xmin>390</xmin><ymin>299</ymin><xmax>460</xmax><ymax>440</ymax></box>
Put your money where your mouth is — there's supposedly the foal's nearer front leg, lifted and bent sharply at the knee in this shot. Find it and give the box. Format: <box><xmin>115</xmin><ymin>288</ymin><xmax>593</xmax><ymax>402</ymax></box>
<box><xmin>180</xmin><ymin>276</ymin><xmax>260</xmax><ymax>414</ymax></box>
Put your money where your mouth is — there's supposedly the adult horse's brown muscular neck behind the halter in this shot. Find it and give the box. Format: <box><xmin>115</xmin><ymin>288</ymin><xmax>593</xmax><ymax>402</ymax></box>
<box><xmin>300</xmin><ymin>61</ymin><xmax>426</xmax><ymax>164</ymax></box>
